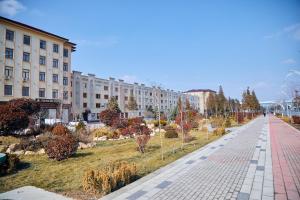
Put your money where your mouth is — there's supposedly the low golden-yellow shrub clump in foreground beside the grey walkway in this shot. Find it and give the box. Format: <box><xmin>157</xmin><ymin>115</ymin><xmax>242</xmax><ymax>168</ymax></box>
<box><xmin>82</xmin><ymin>162</ymin><xmax>137</xmax><ymax>194</ymax></box>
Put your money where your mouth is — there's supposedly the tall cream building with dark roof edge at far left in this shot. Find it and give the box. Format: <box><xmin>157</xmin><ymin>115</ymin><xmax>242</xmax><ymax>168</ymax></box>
<box><xmin>0</xmin><ymin>17</ymin><xmax>76</xmax><ymax>121</ymax></box>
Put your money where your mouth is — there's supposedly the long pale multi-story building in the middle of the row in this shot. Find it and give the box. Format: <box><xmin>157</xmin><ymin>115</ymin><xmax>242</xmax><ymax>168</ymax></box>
<box><xmin>72</xmin><ymin>71</ymin><xmax>199</xmax><ymax>120</ymax></box>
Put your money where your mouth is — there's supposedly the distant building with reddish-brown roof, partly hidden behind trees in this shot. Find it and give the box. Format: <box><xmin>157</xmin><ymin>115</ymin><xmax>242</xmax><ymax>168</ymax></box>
<box><xmin>184</xmin><ymin>89</ymin><xmax>216</xmax><ymax>114</ymax></box>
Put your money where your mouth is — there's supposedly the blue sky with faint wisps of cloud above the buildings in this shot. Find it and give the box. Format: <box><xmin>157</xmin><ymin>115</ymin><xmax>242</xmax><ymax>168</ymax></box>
<box><xmin>0</xmin><ymin>0</ymin><xmax>300</xmax><ymax>100</ymax></box>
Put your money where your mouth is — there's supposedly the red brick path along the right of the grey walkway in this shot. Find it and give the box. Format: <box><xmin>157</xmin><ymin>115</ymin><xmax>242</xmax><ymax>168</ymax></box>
<box><xmin>270</xmin><ymin>116</ymin><xmax>300</xmax><ymax>200</ymax></box>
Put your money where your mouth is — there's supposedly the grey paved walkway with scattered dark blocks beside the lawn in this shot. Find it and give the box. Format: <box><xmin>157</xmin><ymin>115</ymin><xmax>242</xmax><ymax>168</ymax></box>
<box><xmin>103</xmin><ymin>117</ymin><xmax>274</xmax><ymax>200</ymax></box>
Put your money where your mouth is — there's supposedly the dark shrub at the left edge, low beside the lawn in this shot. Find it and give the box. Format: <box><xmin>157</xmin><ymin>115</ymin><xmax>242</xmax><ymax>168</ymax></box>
<box><xmin>0</xmin><ymin>154</ymin><xmax>20</xmax><ymax>176</ymax></box>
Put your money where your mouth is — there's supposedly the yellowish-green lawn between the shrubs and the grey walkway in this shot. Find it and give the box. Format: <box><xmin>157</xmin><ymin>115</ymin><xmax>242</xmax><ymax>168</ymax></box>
<box><xmin>0</xmin><ymin>131</ymin><xmax>218</xmax><ymax>199</ymax></box>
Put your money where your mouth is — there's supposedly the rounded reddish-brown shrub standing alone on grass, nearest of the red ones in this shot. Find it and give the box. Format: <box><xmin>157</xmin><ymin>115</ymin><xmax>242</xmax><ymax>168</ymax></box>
<box><xmin>46</xmin><ymin>134</ymin><xmax>78</xmax><ymax>161</ymax></box>
